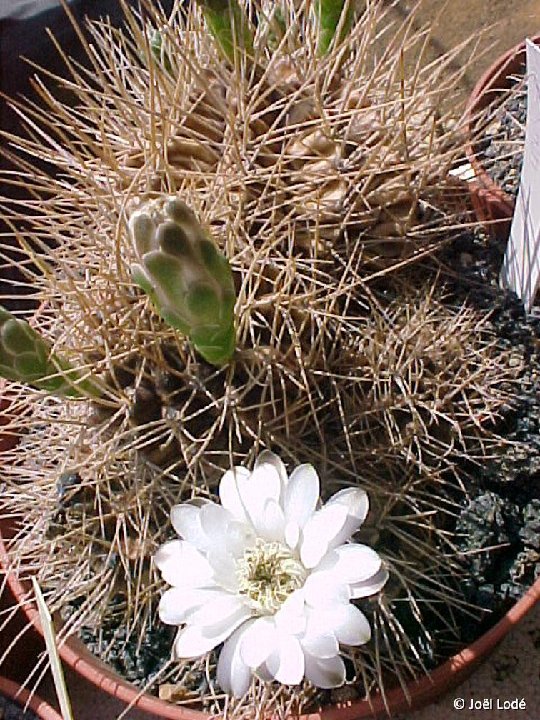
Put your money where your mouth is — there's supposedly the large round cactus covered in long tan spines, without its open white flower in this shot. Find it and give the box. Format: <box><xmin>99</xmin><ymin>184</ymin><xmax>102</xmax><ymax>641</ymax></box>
<box><xmin>3</xmin><ymin>0</ymin><xmax>517</xmax><ymax>718</ymax></box>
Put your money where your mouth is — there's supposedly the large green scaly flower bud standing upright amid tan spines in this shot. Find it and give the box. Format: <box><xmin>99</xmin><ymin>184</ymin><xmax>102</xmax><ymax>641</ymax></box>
<box><xmin>129</xmin><ymin>196</ymin><xmax>236</xmax><ymax>365</ymax></box>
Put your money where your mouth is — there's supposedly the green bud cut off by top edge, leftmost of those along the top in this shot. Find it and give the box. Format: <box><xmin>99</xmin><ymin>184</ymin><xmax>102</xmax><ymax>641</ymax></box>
<box><xmin>197</xmin><ymin>0</ymin><xmax>253</xmax><ymax>65</ymax></box>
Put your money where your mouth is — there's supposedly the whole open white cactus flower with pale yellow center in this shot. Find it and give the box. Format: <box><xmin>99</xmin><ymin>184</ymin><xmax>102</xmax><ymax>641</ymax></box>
<box><xmin>154</xmin><ymin>451</ymin><xmax>388</xmax><ymax>696</ymax></box>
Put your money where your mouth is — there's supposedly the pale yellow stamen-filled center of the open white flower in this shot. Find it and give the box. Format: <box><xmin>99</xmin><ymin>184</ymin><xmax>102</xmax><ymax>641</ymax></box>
<box><xmin>236</xmin><ymin>538</ymin><xmax>307</xmax><ymax>615</ymax></box>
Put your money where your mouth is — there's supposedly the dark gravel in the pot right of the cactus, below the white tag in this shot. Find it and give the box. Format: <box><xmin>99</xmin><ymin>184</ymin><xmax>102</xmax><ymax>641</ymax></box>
<box><xmin>443</xmin><ymin>232</ymin><xmax>540</xmax><ymax>642</ymax></box>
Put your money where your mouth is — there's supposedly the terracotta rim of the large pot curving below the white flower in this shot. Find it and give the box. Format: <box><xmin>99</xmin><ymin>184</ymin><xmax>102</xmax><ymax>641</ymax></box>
<box><xmin>0</xmin><ymin>396</ymin><xmax>540</xmax><ymax>720</ymax></box>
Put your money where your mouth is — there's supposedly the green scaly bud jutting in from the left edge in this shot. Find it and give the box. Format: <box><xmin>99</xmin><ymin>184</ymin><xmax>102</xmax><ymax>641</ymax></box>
<box><xmin>0</xmin><ymin>306</ymin><xmax>100</xmax><ymax>397</ymax></box>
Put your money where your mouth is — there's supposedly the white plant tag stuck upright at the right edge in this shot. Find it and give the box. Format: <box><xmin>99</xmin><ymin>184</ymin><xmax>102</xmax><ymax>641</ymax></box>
<box><xmin>500</xmin><ymin>40</ymin><xmax>540</xmax><ymax>312</ymax></box>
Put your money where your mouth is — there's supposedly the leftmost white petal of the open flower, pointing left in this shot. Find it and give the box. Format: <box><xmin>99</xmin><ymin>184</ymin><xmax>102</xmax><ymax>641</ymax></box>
<box><xmin>154</xmin><ymin>540</ymin><xmax>215</xmax><ymax>587</ymax></box>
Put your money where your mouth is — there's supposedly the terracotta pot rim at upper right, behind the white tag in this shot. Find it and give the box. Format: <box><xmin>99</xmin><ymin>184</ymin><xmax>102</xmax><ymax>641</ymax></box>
<box><xmin>465</xmin><ymin>35</ymin><xmax>540</xmax><ymax>240</ymax></box>
